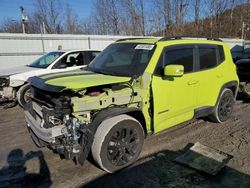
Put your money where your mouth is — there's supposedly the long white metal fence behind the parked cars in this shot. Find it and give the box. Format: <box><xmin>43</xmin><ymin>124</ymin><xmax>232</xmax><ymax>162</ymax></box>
<box><xmin>0</xmin><ymin>33</ymin><xmax>247</xmax><ymax>69</ymax></box>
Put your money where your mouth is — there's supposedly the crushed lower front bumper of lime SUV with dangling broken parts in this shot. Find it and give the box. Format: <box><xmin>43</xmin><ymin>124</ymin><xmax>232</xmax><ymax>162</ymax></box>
<box><xmin>24</xmin><ymin>101</ymin><xmax>93</xmax><ymax>165</ymax></box>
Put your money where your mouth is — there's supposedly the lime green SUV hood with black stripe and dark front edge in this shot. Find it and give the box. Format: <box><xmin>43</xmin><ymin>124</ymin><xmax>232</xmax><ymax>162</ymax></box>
<box><xmin>29</xmin><ymin>70</ymin><xmax>131</xmax><ymax>92</ymax></box>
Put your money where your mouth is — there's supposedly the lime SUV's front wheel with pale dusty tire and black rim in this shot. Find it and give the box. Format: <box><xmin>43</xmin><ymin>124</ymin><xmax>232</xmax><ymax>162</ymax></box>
<box><xmin>91</xmin><ymin>115</ymin><xmax>144</xmax><ymax>173</ymax></box>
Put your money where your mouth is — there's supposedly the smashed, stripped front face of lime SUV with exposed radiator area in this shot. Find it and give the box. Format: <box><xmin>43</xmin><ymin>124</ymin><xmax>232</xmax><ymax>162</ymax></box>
<box><xmin>25</xmin><ymin>88</ymin><xmax>84</xmax><ymax>164</ymax></box>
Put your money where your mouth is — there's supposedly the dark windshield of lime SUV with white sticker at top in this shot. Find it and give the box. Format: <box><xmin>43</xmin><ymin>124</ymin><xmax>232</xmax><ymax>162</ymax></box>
<box><xmin>88</xmin><ymin>43</ymin><xmax>154</xmax><ymax>77</ymax></box>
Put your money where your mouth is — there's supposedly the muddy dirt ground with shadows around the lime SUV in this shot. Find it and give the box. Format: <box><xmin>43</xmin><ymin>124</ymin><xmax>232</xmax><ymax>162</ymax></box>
<box><xmin>0</xmin><ymin>101</ymin><xmax>250</xmax><ymax>188</ymax></box>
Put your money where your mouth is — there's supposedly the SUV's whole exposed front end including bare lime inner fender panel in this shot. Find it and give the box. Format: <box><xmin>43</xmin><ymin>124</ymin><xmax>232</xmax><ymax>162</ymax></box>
<box><xmin>25</xmin><ymin>78</ymin><xmax>141</xmax><ymax>164</ymax></box>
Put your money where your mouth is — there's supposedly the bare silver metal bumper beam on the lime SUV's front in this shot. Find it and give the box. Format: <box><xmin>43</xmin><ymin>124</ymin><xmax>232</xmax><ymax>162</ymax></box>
<box><xmin>24</xmin><ymin>110</ymin><xmax>66</xmax><ymax>144</ymax></box>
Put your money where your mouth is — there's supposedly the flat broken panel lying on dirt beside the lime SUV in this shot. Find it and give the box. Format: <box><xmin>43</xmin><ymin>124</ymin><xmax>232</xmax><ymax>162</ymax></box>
<box><xmin>175</xmin><ymin>142</ymin><xmax>233</xmax><ymax>175</ymax></box>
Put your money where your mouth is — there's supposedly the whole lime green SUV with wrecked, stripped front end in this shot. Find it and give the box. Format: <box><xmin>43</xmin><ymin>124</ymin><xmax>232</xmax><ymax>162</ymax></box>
<box><xmin>25</xmin><ymin>37</ymin><xmax>239</xmax><ymax>173</ymax></box>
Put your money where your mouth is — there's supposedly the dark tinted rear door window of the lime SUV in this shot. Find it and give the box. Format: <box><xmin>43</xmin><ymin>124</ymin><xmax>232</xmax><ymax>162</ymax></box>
<box><xmin>199</xmin><ymin>47</ymin><xmax>217</xmax><ymax>70</ymax></box>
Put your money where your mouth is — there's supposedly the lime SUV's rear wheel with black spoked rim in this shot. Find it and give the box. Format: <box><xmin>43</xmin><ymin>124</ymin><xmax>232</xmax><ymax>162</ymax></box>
<box><xmin>209</xmin><ymin>89</ymin><xmax>235</xmax><ymax>123</ymax></box>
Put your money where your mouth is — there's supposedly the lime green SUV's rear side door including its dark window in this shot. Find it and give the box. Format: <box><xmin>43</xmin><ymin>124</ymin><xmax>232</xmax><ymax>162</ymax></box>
<box><xmin>196</xmin><ymin>44</ymin><xmax>226</xmax><ymax>107</ymax></box>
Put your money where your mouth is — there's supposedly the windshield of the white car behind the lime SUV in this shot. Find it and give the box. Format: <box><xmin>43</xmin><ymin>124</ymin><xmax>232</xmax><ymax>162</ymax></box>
<box><xmin>29</xmin><ymin>52</ymin><xmax>64</xmax><ymax>69</ymax></box>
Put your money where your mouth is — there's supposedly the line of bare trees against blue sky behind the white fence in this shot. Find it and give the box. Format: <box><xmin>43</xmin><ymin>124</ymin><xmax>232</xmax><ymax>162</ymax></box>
<box><xmin>0</xmin><ymin>0</ymin><xmax>250</xmax><ymax>37</ymax></box>
